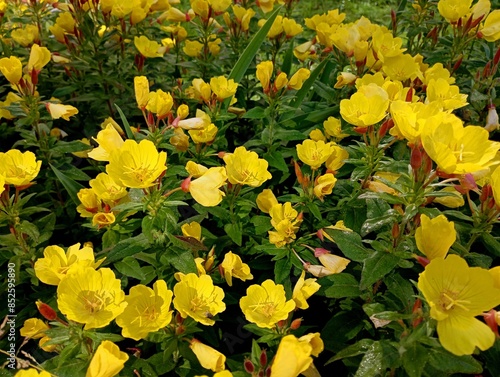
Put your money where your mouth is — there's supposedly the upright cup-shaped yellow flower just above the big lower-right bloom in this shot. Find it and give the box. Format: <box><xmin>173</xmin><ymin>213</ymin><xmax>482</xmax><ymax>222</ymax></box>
<box><xmin>415</xmin><ymin>214</ymin><xmax>457</xmax><ymax>260</ymax></box>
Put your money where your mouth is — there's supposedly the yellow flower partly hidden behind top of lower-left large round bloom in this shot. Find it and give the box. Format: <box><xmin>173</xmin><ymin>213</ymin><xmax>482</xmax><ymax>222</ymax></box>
<box><xmin>35</xmin><ymin>243</ymin><xmax>104</xmax><ymax>285</ymax></box>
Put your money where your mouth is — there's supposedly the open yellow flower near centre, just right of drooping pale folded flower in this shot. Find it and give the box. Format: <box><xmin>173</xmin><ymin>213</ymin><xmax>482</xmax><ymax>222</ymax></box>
<box><xmin>224</xmin><ymin>147</ymin><xmax>272</xmax><ymax>187</ymax></box>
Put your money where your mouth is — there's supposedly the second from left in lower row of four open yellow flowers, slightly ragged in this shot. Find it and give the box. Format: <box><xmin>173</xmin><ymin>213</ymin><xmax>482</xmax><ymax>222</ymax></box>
<box><xmin>116</xmin><ymin>280</ymin><xmax>173</xmax><ymax>340</ymax></box>
